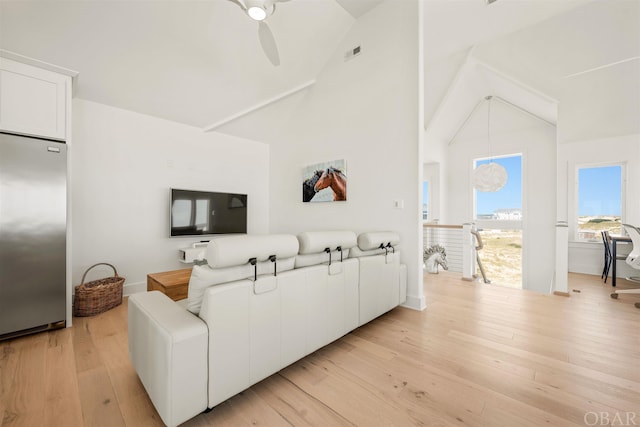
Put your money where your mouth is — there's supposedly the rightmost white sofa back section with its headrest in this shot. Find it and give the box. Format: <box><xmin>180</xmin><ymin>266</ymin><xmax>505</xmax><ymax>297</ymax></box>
<box><xmin>351</xmin><ymin>231</ymin><xmax>406</xmax><ymax>326</ymax></box>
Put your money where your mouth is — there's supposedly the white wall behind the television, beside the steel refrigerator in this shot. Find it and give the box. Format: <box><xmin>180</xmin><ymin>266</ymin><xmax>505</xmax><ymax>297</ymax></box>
<box><xmin>70</xmin><ymin>99</ymin><xmax>269</xmax><ymax>292</ymax></box>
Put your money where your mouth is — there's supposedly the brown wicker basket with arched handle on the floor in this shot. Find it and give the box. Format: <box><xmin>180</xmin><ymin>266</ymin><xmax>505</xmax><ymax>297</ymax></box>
<box><xmin>73</xmin><ymin>262</ymin><xmax>124</xmax><ymax>317</ymax></box>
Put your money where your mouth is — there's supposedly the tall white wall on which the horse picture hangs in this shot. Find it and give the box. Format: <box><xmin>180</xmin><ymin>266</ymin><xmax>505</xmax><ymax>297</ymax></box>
<box><xmin>270</xmin><ymin>0</ymin><xmax>423</xmax><ymax>308</ymax></box>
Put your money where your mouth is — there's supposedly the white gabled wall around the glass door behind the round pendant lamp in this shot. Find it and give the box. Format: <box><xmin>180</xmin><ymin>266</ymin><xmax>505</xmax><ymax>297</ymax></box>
<box><xmin>440</xmin><ymin>103</ymin><xmax>556</xmax><ymax>293</ymax></box>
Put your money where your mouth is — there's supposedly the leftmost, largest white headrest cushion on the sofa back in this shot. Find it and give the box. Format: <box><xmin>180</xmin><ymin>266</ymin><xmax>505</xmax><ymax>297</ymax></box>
<box><xmin>206</xmin><ymin>234</ymin><xmax>298</xmax><ymax>268</ymax></box>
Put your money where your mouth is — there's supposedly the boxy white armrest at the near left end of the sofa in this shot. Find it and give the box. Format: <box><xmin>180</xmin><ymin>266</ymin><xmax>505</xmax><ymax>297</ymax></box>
<box><xmin>128</xmin><ymin>291</ymin><xmax>208</xmax><ymax>426</ymax></box>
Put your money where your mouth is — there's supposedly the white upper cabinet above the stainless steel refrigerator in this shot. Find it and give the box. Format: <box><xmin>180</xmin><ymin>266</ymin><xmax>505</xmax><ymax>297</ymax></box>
<box><xmin>0</xmin><ymin>57</ymin><xmax>71</xmax><ymax>140</ymax></box>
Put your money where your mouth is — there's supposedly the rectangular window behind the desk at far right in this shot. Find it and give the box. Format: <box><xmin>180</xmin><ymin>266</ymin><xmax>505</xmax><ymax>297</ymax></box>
<box><xmin>576</xmin><ymin>164</ymin><xmax>624</xmax><ymax>241</ymax></box>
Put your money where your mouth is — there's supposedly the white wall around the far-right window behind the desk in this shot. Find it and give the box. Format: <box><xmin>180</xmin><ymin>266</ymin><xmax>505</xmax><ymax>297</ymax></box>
<box><xmin>558</xmin><ymin>134</ymin><xmax>640</xmax><ymax>276</ymax></box>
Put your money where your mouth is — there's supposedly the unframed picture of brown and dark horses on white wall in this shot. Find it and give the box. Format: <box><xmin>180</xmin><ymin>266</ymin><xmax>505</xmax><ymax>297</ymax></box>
<box><xmin>302</xmin><ymin>160</ymin><xmax>347</xmax><ymax>203</ymax></box>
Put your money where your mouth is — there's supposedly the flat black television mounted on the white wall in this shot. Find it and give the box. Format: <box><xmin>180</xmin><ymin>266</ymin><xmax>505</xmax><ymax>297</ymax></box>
<box><xmin>170</xmin><ymin>188</ymin><xmax>247</xmax><ymax>237</ymax></box>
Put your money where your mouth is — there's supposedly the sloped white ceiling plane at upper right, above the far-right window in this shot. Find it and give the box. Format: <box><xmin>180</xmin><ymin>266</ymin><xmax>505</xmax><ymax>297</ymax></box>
<box><xmin>474</xmin><ymin>0</ymin><xmax>640</xmax><ymax>98</ymax></box>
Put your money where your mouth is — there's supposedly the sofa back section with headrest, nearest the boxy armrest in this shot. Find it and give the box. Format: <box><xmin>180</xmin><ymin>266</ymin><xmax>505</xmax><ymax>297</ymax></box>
<box><xmin>198</xmin><ymin>235</ymin><xmax>298</xmax><ymax>407</ymax></box>
